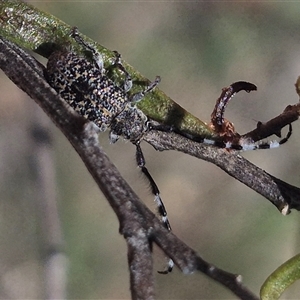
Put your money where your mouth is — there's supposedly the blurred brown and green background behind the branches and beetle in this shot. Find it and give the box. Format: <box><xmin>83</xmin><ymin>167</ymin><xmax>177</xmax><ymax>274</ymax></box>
<box><xmin>0</xmin><ymin>1</ymin><xmax>300</xmax><ymax>299</ymax></box>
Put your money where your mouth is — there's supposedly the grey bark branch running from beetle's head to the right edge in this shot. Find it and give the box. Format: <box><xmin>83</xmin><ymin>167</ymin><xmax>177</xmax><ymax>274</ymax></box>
<box><xmin>144</xmin><ymin>130</ymin><xmax>300</xmax><ymax>214</ymax></box>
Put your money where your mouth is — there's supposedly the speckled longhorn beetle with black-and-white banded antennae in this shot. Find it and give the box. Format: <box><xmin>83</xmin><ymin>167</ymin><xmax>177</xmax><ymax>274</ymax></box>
<box><xmin>46</xmin><ymin>28</ymin><xmax>291</xmax><ymax>273</ymax></box>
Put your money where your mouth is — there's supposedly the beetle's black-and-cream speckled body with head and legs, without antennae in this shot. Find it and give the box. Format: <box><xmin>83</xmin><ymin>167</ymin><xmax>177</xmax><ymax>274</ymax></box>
<box><xmin>47</xmin><ymin>33</ymin><xmax>160</xmax><ymax>143</ymax></box>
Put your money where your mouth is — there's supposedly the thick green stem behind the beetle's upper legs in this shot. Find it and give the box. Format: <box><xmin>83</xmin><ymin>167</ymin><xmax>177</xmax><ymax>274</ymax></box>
<box><xmin>0</xmin><ymin>0</ymin><xmax>217</xmax><ymax>139</ymax></box>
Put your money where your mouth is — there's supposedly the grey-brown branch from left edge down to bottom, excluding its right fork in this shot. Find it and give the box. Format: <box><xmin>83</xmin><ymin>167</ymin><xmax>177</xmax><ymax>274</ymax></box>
<box><xmin>0</xmin><ymin>35</ymin><xmax>155</xmax><ymax>299</ymax></box>
